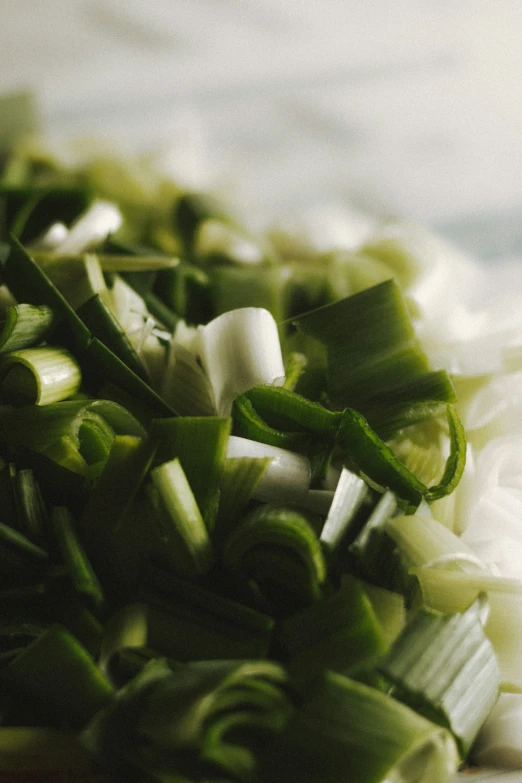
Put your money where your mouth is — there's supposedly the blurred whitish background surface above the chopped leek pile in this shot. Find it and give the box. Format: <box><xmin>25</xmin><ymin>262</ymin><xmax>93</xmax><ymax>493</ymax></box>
<box><xmin>0</xmin><ymin>0</ymin><xmax>522</xmax><ymax>256</ymax></box>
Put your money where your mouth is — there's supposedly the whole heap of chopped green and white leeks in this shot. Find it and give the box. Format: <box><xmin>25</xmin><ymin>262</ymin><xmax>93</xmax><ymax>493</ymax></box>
<box><xmin>0</xmin><ymin>93</ymin><xmax>522</xmax><ymax>783</ymax></box>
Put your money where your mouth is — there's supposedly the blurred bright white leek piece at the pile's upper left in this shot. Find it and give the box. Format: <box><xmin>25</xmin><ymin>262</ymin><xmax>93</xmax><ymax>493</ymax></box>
<box><xmin>54</xmin><ymin>200</ymin><xmax>123</xmax><ymax>255</ymax></box>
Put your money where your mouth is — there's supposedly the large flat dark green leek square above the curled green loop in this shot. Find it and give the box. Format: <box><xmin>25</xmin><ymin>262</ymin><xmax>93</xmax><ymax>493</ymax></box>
<box><xmin>293</xmin><ymin>280</ymin><xmax>455</xmax><ymax>434</ymax></box>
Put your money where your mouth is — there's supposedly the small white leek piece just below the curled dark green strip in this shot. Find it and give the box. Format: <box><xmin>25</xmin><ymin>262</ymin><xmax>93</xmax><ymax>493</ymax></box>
<box><xmin>227</xmin><ymin>435</ymin><xmax>311</xmax><ymax>503</ymax></box>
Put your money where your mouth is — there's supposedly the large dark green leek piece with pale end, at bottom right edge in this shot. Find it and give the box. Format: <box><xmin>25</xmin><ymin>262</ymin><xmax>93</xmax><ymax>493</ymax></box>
<box><xmin>260</xmin><ymin>672</ymin><xmax>458</xmax><ymax>783</ymax></box>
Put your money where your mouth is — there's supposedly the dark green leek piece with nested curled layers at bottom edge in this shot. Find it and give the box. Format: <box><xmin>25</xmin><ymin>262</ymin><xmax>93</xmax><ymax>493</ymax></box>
<box><xmin>84</xmin><ymin>660</ymin><xmax>293</xmax><ymax>783</ymax></box>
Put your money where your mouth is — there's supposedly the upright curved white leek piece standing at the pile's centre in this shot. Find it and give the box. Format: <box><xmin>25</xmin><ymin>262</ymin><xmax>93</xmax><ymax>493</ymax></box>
<box><xmin>199</xmin><ymin>307</ymin><xmax>285</xmax><ymax>416</ymax></box>
